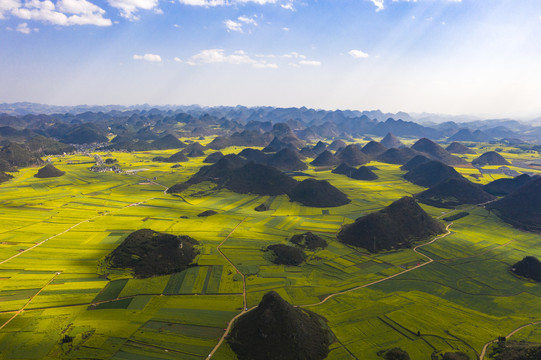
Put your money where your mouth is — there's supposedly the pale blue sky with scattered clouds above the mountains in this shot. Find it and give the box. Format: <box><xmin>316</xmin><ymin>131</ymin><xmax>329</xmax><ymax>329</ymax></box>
<box><xmin>0</xmin><ymin>0</ymin><xmax>541</xmax><ymax>118</ymax></box>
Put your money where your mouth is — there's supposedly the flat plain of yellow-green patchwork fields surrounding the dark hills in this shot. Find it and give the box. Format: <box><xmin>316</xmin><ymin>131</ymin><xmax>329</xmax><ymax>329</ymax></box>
<box><xmin>0</xmin><ymin>138</ymin><xmax>541</xmax><ymax>359</ymax></box>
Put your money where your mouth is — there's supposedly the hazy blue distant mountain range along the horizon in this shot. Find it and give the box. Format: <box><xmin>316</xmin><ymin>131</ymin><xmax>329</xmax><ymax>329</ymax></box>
<box><xmin>0</xmin><ymin>102</ymin><xmax>541</xmax><ymax>143</ymax></box>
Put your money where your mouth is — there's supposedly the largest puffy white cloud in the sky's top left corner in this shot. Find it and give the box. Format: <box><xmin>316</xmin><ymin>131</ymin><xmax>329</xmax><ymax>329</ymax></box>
<box><xmin>7</xmin><ymin>0</ymin><xmax>112</xmax><ymax>26</ymax></box>
